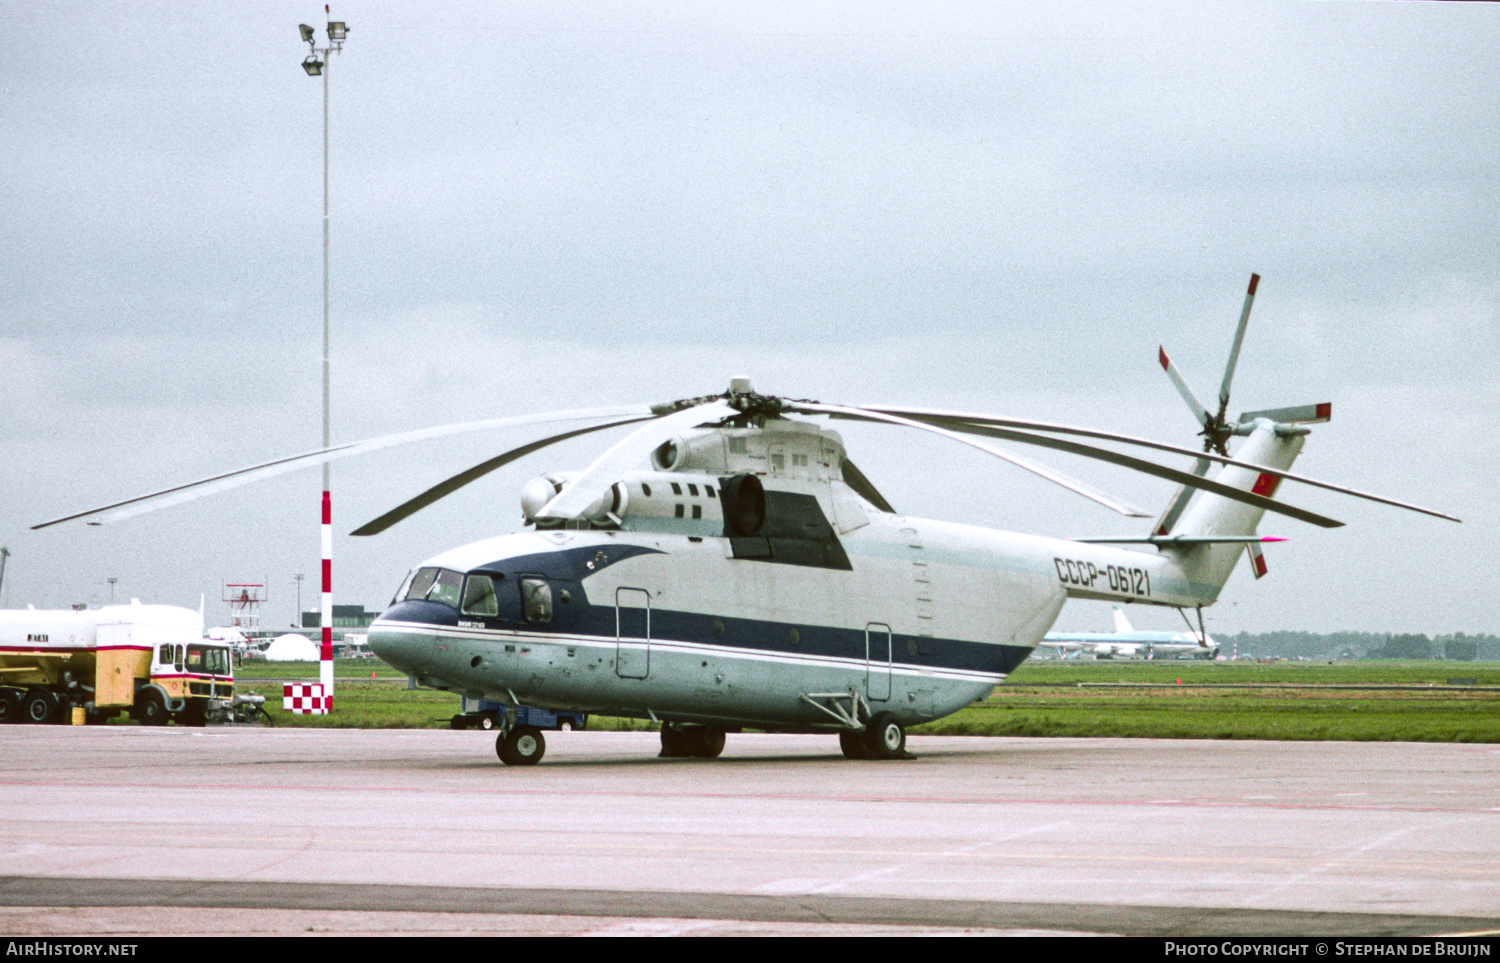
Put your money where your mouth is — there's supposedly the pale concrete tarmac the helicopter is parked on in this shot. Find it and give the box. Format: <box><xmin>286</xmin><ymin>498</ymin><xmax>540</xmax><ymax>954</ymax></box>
<box><xmin>0</xmin><ymin>726</ymin><xmax>1500</xmax><ymax>936</ymax></box>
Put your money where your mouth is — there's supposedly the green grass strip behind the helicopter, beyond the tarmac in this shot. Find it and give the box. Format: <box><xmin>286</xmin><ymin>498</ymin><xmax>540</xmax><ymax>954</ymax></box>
<box><xmin>225</xmin><ymin>660</ymin><xmax>1500</xmax><ymax>743</ymax></box>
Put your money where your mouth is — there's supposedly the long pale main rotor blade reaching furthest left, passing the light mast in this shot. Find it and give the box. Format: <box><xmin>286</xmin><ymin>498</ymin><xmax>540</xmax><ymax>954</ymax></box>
<box><xmin>32</xmin><ymin>405</ymin><xmax>651</xmax><ymax>530</ymax></box>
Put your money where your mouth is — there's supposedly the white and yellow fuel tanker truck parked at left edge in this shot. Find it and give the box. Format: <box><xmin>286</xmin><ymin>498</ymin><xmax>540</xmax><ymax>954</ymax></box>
<box><xmin>0</xmin><ymin>599</ymin><xmax>234</xmax><ymax>726</ymax></box>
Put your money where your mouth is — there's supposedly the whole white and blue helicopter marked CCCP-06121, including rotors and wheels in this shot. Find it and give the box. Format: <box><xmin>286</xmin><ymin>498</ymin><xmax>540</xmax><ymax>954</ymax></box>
<box><xmin>48</xmin><ymin>275</ymin><xmax>1458</xmax><ymax>765</ymax></box>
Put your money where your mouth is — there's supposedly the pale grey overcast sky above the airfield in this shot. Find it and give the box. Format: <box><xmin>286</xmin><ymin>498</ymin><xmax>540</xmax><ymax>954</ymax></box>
<box><xmin>0</xmin><ymin>0</ymin><xmax>1500</xmax><ymax>635</ymax></box>
